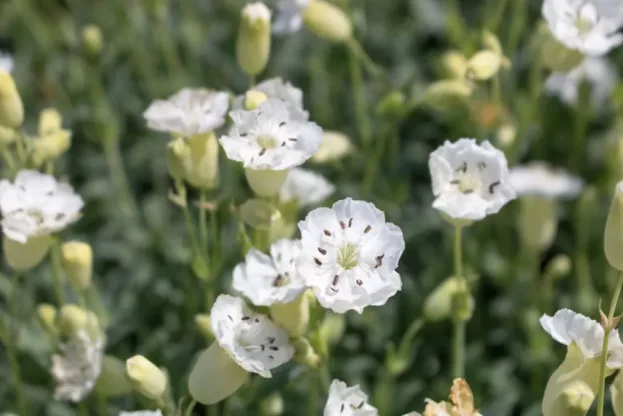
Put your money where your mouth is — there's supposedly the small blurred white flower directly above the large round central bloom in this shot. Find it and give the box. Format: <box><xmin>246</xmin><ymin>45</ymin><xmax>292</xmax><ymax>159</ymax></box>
<box><xmin>279</xmin><ymin>168</ymin><xmax>335</xmax><ymax>207</ymax></box>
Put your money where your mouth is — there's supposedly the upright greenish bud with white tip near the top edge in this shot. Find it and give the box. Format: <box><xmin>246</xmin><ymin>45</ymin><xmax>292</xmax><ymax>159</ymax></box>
<box><xmin>236</xmin><ymin>2</ymin><xmax>270</xmax><ymax>76</ymax></box>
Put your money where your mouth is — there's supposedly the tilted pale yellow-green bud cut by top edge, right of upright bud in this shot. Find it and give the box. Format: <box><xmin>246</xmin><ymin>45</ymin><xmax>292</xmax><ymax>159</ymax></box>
<box><xmin>303</xmin><ymin>0</ymin><xmax>353</xmax><ymax>42</ymax></box>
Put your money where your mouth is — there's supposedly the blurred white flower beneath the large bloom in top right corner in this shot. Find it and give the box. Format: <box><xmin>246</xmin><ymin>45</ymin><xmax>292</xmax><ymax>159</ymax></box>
<box><xmin>545</xmin><ymin>57</ymin><xmax>618</xmax><ymax>108</ymax></box>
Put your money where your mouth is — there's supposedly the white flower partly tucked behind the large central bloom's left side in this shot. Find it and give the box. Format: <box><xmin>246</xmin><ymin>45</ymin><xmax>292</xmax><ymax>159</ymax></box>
<box><xmin>233</xmin><ymin>239</ymin><xmax>305</xmax><ymax>306</ymax></box>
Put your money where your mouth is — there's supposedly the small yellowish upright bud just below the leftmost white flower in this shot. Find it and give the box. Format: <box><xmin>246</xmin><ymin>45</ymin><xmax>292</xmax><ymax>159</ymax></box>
<box><xmin>61</xmin><ymin>241</ymin><xmax>93</xmax><ymax>292</ymax></box>
